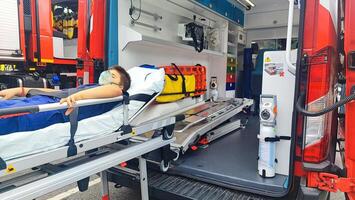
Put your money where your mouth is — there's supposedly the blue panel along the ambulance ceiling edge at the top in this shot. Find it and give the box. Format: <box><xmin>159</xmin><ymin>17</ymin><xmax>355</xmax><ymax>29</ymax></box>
<box><xmin>195</xmin><ymin>0</ymin><xmax>244</xmax><ymax>26</ymax></box>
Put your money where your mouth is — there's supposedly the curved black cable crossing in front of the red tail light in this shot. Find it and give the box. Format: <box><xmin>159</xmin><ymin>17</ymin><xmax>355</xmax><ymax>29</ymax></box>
<box><xmin>296</xmin><ymin>93</ymin><xmax>355</xmax><ymax>117</ymax></box>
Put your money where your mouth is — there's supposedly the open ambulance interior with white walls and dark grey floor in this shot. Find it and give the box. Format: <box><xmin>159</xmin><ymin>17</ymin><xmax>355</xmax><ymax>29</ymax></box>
<box><xmin>119</xmin><ymin>0</ymin><xmax>300</xmax><ymax>196</ymax></box>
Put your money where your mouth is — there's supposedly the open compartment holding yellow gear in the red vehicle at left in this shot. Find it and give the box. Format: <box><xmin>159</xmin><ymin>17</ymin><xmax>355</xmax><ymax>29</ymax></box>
<box><xmin>52</xmin><ymin>0</ymin><xmax>78</xmax><ymax>59</ymax></box>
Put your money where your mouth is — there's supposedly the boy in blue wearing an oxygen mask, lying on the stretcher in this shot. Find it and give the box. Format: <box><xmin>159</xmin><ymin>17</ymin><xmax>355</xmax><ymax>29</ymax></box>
<box><xmin>0</xmin><ymin>66</ymin><xmax>131</xmax><ymax>135</ymax></box>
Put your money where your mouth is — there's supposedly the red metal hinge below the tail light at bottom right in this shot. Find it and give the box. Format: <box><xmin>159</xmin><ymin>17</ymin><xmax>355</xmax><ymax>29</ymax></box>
<box><xmin>318</xmin><ymin>173</ymin><xmax>355</xmax><ymax>192</ymax></box>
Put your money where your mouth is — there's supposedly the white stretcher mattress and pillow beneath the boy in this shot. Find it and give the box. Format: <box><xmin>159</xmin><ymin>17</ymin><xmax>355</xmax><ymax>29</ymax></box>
<box><xmin>0</xmin><ymin>67</ymin><xmax>165</xmax><ymax>161</ymax></box>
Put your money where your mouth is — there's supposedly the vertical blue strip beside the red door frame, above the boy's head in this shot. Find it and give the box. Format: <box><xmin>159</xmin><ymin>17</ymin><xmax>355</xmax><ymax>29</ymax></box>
<box><xmin>107</xmin><ymin>0</ymin><xmax>118</xmax><ymax>66</ymax></box>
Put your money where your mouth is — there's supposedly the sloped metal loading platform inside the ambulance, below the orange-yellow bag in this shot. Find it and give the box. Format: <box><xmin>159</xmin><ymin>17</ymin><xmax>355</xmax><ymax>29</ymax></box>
<box><xmin>171</xmin><ymin>98</ymin><xmax>253</xmax><ymax>154</ymax></box>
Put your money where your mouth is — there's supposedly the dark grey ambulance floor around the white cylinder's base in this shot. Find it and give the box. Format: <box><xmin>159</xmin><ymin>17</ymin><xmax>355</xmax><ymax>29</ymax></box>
<box><xmin>169</xmin><ymin>116</ymin><xmax>288</xmax><ymax>193</ymax></box>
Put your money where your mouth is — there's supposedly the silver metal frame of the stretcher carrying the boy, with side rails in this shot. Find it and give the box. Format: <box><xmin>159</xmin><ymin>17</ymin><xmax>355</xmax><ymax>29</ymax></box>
<box><xmin>0</xmin><ymin>95</ymin><xmax>179</xmax><ymax>199</ymax></box>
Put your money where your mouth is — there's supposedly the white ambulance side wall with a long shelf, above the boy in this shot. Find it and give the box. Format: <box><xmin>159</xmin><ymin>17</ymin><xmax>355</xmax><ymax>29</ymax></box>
<box><xmin>118</xmin><ymin>0</ymin><xmax>228</xmax><ymax>96</ymax></box>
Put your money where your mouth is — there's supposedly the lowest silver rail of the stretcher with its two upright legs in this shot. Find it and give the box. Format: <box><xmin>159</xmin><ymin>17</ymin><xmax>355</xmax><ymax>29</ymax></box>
<box><xmin>0</xmin><ymin>136</ymin><xmax>174</xmax><ymax>200</ymax></box>
